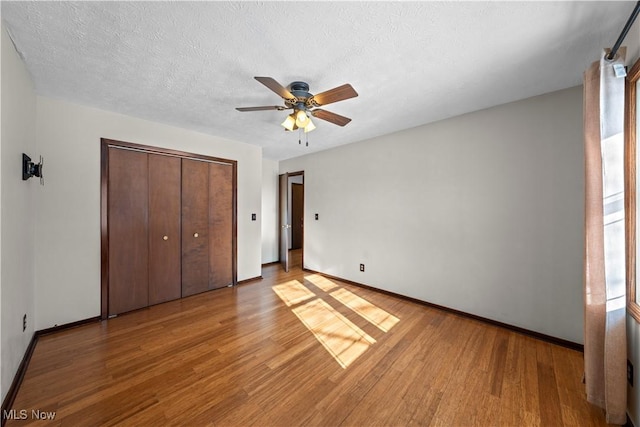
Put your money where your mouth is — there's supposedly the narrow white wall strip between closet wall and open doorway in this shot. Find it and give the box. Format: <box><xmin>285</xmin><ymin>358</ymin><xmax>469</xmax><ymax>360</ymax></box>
<box><xmin>262</xmin><ymin>159</ymin><xmax>279</xmax><ymax>264</ymax></box>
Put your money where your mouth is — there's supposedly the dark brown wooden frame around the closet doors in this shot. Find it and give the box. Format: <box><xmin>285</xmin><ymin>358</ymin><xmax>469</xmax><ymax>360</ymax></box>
<box><xmin>100</xmin><ymin>138</ymin><xmax>238</xmax><ymax>320</ymax></box>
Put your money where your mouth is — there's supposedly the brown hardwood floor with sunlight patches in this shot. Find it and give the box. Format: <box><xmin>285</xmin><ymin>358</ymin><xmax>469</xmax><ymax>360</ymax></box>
<box><xmin>7</xmin><ymin>256</ymin><xmax>606</xmax><ymax>426</ymax></box>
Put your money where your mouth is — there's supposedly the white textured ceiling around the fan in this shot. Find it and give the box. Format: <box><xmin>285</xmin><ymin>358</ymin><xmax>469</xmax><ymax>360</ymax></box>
<box><xmin>1</xmin><ymin>1</ymin><xmax>635</xmax><ymax>160</ymax></box>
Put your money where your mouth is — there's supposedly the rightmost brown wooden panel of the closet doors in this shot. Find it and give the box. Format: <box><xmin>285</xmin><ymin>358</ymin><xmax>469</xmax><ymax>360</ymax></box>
<box><xmin>209</xmin><ymin>163</ymin><xmax>233</xmax><ymax>289</ymax></box>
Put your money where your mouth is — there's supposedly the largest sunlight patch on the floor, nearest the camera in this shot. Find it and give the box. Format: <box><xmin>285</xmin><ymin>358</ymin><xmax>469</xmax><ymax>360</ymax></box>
<box><xmin>292</xmin><ymin>299</ymin><xmax>376</xmax><ymax>368</ymax></box>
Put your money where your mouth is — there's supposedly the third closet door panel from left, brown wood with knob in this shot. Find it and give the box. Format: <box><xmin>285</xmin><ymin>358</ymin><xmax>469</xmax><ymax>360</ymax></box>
<box><xmin>182</xmin><ymin>159</ymin><xmax>210</xmax><ymax>297</ymax></box>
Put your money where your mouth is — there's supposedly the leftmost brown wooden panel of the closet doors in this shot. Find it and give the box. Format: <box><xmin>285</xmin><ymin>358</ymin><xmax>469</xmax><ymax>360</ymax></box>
<box><xmin>107</xmin><ymin>148</ymin><xmax>149</xmax><ymax>315</ymax></box>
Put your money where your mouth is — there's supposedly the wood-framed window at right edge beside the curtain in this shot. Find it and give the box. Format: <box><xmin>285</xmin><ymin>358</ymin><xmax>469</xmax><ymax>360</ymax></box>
<box><xmin>624</xmin><ymin>60</ymin><xmax>640</xmax><ymax>322</ymax></box>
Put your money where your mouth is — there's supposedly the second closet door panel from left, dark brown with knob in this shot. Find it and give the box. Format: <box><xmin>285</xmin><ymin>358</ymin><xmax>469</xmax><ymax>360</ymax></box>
<box><xmin>149</xmin><ymin>154</ymin><xmax>182</xmax><ymax>305</ymax></box>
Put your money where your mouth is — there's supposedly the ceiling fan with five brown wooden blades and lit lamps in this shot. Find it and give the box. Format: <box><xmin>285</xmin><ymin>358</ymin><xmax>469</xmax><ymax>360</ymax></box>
<box><xmin>236</xmin><ymin>77</ymin><xmax>358</xmax><ymax>132</ymax></box>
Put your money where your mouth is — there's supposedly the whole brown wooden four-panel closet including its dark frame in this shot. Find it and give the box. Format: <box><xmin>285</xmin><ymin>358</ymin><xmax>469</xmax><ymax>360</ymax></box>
<box><xmin>101</xmin><ymin>139</ymin><xmax>237</xmax><ymax>318</ymax></box>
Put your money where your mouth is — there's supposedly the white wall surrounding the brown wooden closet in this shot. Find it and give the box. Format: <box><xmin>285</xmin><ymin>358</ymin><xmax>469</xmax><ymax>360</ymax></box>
<box><xmin>31</xmin><ymin>97</ymin><xmax>262</xmax><ymax>329</ymax></box>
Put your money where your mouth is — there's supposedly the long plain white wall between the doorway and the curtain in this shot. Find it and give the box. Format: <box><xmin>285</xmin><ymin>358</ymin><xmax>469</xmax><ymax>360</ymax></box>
<box><xmin>280</xmin><ymin>87</ymin><xmax>584</xmax><ymax>343</ymax></box>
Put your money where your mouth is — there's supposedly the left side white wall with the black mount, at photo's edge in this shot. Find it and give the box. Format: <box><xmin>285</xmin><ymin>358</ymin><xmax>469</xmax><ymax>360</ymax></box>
<box><xmin>0</xmin><ymin>26</ymin><xmax>39</xmax><ymax>400</ymax></box>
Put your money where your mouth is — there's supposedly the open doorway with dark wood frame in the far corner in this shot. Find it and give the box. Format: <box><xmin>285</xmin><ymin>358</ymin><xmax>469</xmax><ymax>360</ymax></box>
<box><xmin>279</xmin><ymin>171</ymin><xmax>304</xmax><ymax>271</ymax></box>
